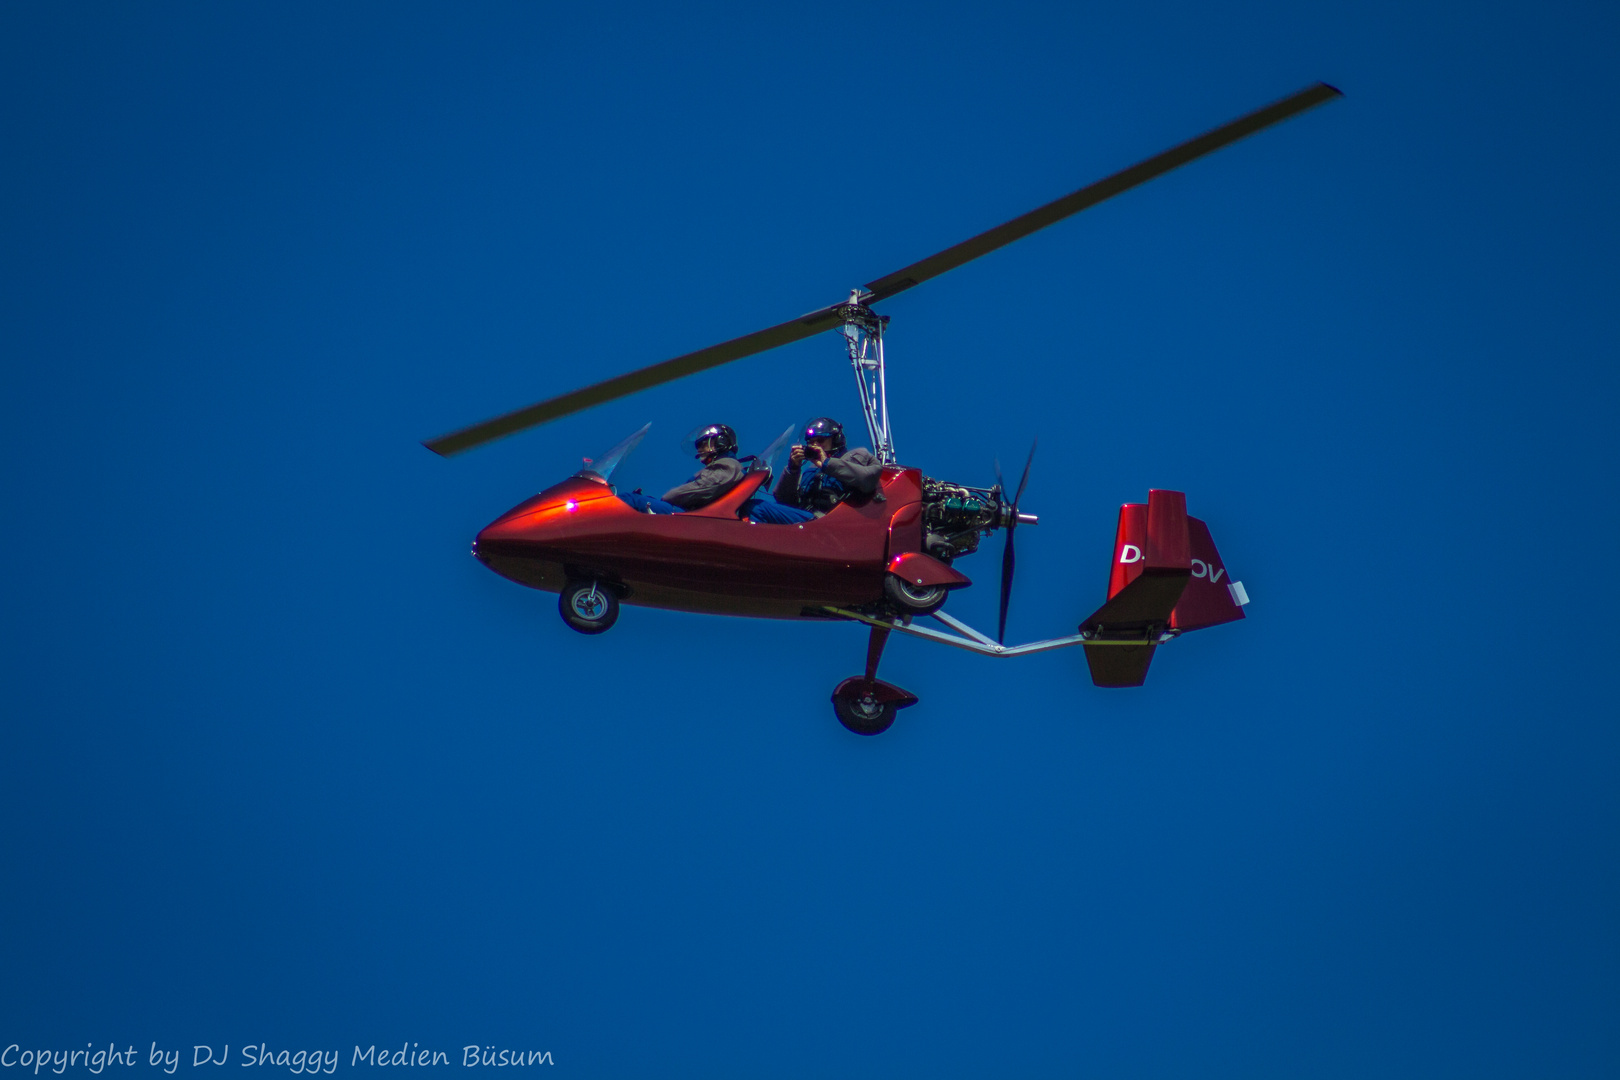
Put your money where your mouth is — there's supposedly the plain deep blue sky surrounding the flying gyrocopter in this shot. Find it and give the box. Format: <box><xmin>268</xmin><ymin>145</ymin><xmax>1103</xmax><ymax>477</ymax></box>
<box><xmin>0</xmin><ymin>3</ymin><xmax>1620</xmax><ymax>1080</ymax></box>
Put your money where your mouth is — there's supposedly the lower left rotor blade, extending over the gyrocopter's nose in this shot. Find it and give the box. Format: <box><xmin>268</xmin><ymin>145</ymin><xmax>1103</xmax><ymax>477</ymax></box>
<box><xmin>421</xmin><ymin>308</ymin><xmax>842</xmax><ymax>457</ymax></box>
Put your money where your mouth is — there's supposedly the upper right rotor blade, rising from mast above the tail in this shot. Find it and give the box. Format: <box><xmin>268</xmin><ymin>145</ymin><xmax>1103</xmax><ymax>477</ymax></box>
<box><xmin>860</xmin><ymin>83</ymin><xmax>1343</xmax><ymax>304</ymax></box>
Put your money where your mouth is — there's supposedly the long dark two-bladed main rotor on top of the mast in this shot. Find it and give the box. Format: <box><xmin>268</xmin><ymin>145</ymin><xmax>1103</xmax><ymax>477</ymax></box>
<box><xmin>423</xmin><ymin>83</ymin><xmax>1341</xmax><ymax>456</ymax></box>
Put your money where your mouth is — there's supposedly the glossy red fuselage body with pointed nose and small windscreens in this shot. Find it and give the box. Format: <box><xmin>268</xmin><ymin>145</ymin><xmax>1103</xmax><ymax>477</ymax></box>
<box><xmin>473</xmin><ymin>466</ymin><xmax>967</xmax><ymax>619</ymax></box>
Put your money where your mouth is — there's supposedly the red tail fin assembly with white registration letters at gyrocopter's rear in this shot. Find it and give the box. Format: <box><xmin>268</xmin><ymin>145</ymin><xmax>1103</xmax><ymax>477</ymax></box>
<box><xmin>1081</xmin><ymin>491</ymin><xmax>1249</xmax><ymax>687</ymax></box>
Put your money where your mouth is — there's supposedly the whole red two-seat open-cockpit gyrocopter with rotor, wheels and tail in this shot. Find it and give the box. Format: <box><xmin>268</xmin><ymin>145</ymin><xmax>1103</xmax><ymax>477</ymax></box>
<box><xmin>424</xmin><ymin>83</ymin><xmax>1340</xmax><ymax>735</ymax></box>
